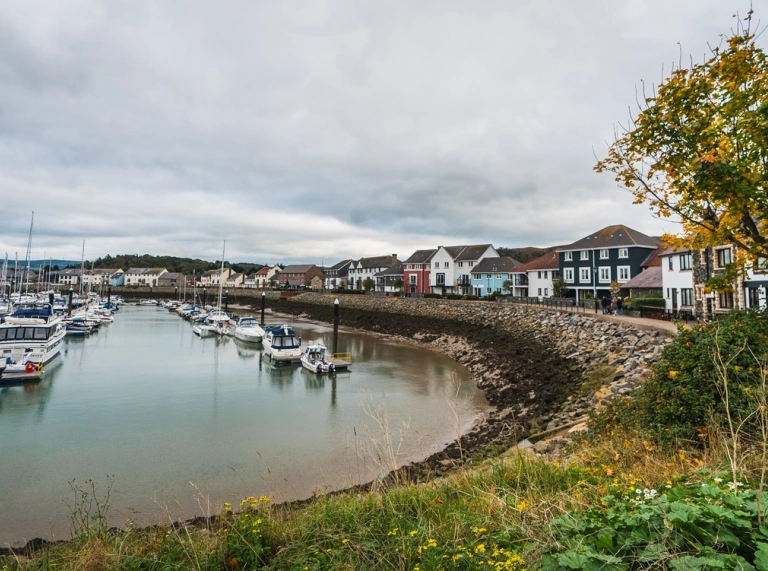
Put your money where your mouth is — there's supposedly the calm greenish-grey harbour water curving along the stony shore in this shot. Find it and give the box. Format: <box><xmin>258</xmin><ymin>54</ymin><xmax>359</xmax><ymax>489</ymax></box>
<box><xmin>0</xmin><ymin>307</ymin><xmax>486</xmax><ymax>545</ymax></box>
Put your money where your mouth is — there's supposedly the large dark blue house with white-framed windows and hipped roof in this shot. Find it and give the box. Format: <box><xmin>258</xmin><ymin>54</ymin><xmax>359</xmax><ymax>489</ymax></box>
<box><xmin>557</xmin><ymin>224</ymin><xmax>660</xmax><ymax>301</ymax></box>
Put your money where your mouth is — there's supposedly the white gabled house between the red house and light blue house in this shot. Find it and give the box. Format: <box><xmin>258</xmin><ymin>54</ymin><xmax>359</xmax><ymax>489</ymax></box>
<box><xmin>429</xmin><ymin>244</ymin><xmax>499</xmax><ymax>295</ymax></box>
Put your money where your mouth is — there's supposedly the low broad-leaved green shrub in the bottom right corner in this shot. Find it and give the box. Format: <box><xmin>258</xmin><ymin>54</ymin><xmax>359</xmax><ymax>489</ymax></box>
<box><xmin>541</xmin><ymin>477</ymin><xmax>768</xmax><ymax>571</ymax></box>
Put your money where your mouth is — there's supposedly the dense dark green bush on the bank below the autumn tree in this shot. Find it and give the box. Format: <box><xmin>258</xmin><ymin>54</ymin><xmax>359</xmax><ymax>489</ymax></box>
<box><xmin>592</xmin><ymin>311</ymin><xmax>768</xmax><ymax>442</ymax></box>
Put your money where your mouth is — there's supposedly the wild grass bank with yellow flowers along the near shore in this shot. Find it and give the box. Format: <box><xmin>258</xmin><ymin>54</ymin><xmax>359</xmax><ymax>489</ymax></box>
<box><xmin>0</xmin><ymin>435</ymin><xmax>722</xmax><ymax>571</ymax></box>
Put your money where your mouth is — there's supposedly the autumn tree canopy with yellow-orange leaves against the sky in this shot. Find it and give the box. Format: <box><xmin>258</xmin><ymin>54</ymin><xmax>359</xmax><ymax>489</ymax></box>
<box><xmin>595</xmin><ymin>11</ymin><xmax>768</xmax><ymax>265</ymax></box>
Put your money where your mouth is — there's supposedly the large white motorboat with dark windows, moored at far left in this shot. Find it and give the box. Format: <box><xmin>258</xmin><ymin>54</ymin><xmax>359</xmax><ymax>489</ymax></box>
<box><xmin>0</xmin><ymin>305</ymin><xmax>66</xmax><ymax>365</ymax></box>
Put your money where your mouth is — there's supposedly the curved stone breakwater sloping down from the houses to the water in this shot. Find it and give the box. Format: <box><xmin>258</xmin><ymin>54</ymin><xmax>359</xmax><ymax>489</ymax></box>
<box><xmin>272</xmin><ymin>293</ymin><xmax>669</xmax><ymax>467</ymax></box>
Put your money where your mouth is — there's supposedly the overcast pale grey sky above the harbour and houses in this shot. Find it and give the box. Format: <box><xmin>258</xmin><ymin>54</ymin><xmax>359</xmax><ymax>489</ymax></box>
<box><xmin>0</xmin><ymin>0</ymin><xmax>756</xmax><ymax>265</ymax></box>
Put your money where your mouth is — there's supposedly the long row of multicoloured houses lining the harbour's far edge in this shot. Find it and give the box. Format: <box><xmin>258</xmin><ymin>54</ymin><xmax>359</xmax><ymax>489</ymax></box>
<box><xmin>3</xmin><ymin>225</ymin><xmax>768</xmax><ymax>319</ymax></box>
